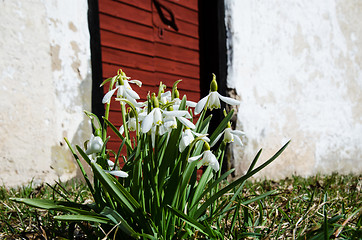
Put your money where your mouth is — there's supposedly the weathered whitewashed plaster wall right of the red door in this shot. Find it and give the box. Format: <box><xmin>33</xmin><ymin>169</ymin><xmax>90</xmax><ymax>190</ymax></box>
<box><xmin>225</xmin><ymin>0</ymin><xmax>362</xmax><ymax>178</ymax></box>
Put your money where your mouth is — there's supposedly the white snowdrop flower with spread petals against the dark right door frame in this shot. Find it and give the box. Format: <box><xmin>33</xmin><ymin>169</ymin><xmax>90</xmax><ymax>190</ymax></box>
<box><xmin>195</xmin><ymin>74</ymin><xmax>240</xmax><ymax>114</ymax></box>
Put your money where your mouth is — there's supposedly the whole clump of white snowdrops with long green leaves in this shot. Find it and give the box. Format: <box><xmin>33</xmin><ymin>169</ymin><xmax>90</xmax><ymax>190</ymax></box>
<box><xmin>14</xmin><ymin>70</ymin><xmax>287</xmax><ymax>239</ymax></box>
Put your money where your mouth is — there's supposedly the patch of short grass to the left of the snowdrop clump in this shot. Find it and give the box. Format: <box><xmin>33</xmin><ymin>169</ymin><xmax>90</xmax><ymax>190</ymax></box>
<box><xmin>0</xmin><ymin>181</ymin><xmax>90</xmax><ymax>239</ymax></box>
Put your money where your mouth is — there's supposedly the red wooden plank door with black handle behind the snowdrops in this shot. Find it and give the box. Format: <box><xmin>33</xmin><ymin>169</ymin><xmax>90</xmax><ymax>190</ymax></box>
<box><xmin>99</xmin><ymin>0</ymin><xmax>200</xmax><ymax>149</ymax></box>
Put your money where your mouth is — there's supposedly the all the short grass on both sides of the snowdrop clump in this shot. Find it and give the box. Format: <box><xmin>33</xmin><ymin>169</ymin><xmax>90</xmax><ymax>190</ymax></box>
<box><xmin>0</xmin><ymin>174</ymin><xmax>362</xmax><ymax>239</ymax></box>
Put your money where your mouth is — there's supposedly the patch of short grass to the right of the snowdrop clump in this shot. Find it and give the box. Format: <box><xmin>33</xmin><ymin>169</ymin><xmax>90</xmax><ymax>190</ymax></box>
<box><xmin>236</xmin><ymin>174</ymin><xmax>362</xmax><ymax>239</ymax></box>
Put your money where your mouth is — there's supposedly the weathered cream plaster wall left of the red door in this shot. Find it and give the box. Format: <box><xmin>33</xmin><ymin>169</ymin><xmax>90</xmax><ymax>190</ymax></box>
<box><xmin>0</xmin><ymin>0</ymin><xmax>91</xmax><ymax>186</ymax></box>
